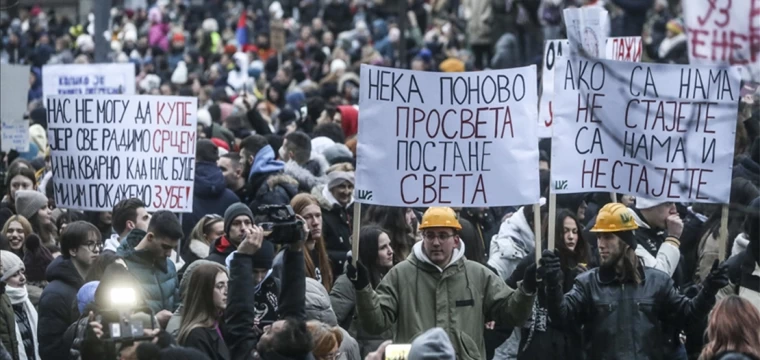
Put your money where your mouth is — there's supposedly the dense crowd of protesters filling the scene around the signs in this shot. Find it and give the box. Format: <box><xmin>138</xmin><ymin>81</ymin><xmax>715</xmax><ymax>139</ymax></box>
<box><xmin>0</xmin><ymin>0</ymin><xmax>760</xmax><ymax>360</ymax></box>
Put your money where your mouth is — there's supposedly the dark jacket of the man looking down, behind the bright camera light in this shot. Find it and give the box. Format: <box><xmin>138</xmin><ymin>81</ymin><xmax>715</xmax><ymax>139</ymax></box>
<box><xmin>116</xmin><ymin>229</ymin><xmax>179</xmax><ymax>314</ymax></box>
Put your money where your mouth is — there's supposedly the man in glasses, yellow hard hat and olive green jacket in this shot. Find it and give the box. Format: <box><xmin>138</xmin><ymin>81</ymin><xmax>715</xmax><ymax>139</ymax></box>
<box><xmin>347</xmin><ymin>207</ymin><xmax>536</xmax><ymax>360</ymax></box>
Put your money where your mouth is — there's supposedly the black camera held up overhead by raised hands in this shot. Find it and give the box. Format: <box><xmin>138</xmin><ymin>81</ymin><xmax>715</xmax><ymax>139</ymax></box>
<box><xmin>256</xmin><ymin>205</ymin><xmax>306</xmax><ymax>244</ymax></box>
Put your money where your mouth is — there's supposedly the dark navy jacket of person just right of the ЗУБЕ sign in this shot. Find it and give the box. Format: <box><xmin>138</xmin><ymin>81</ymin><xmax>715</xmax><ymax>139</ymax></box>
<box><xmin>182</xmin><ymin>161</ymin><xmax>240</xmax><ymax>240</ymax></box>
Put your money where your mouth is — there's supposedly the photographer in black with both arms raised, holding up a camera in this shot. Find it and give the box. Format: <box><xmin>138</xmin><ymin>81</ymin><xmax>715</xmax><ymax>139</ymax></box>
<box><xmin>225</xmin><ymin>221</ymin><xmax>313</xmax><ymax>360</ymax></box>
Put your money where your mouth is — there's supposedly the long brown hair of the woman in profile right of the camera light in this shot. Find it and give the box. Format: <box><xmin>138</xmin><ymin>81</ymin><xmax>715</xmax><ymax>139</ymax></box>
<box><xmin>177</xmin><ymin>264</ymin><xmax>225</xmax><ymax>345</ymax></box>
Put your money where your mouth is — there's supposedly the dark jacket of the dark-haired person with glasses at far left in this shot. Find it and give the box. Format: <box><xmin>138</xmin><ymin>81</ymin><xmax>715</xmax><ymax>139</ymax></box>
<box><xmin>37</xmin><ymin>256</ymin><xmax>84</xmax><ymax>360</ymax></box>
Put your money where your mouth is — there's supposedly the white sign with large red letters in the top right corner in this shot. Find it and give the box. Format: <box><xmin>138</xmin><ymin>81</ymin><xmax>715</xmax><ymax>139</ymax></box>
<box><xmin>683</xmin><ymin>0</ymin><xmax>760</xmax><ymax>82</ymax></box>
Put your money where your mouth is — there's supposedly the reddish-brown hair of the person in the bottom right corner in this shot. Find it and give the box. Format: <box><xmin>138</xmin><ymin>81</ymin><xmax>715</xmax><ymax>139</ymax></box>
<box><xmin>699</xmin><ymin>295</ymin><xmax>760</xmax><ymax>360</ymax></box>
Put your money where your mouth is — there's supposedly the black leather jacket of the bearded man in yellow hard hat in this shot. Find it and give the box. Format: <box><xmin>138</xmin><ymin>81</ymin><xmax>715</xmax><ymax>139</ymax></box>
<box><xmin>546</xmin><ymin>265</ymin><xmax>715</xmax><ymax>360</ymax></box>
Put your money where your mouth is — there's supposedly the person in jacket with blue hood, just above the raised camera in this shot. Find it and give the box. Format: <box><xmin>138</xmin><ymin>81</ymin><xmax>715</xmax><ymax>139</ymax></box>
<box><xmin>240</xmin><ymin>135</ymin><xmax>298</xmax><ymax>214</ymax></box>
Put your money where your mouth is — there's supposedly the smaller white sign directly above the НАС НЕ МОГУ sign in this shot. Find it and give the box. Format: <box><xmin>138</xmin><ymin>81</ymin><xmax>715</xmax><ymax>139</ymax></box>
<box><xmin>42</xmin><ymin>63</ymin><xmax>135</xmax><ymax>99</ymax></box>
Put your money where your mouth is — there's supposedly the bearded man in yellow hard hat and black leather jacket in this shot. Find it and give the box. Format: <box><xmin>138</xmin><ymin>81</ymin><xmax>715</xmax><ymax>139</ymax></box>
<box><xmin>538</xmin><ymin>203</ymin><xmax>728</xmax><ymax>360</ymax></box>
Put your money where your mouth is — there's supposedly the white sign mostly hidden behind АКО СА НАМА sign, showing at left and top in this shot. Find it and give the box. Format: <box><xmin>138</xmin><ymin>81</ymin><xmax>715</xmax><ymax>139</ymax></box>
<box><xmin>538</xmin><ymin>36</ymin><xmax>641</xmax><ymax>138</ymax></box>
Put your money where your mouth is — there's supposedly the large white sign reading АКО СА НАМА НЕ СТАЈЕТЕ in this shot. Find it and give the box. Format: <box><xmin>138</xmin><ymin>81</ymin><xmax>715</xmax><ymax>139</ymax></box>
<box><xmin>551</xmin><ymin>58</ymin><xmax>739</xmax><ymax>203</ymax></box>
